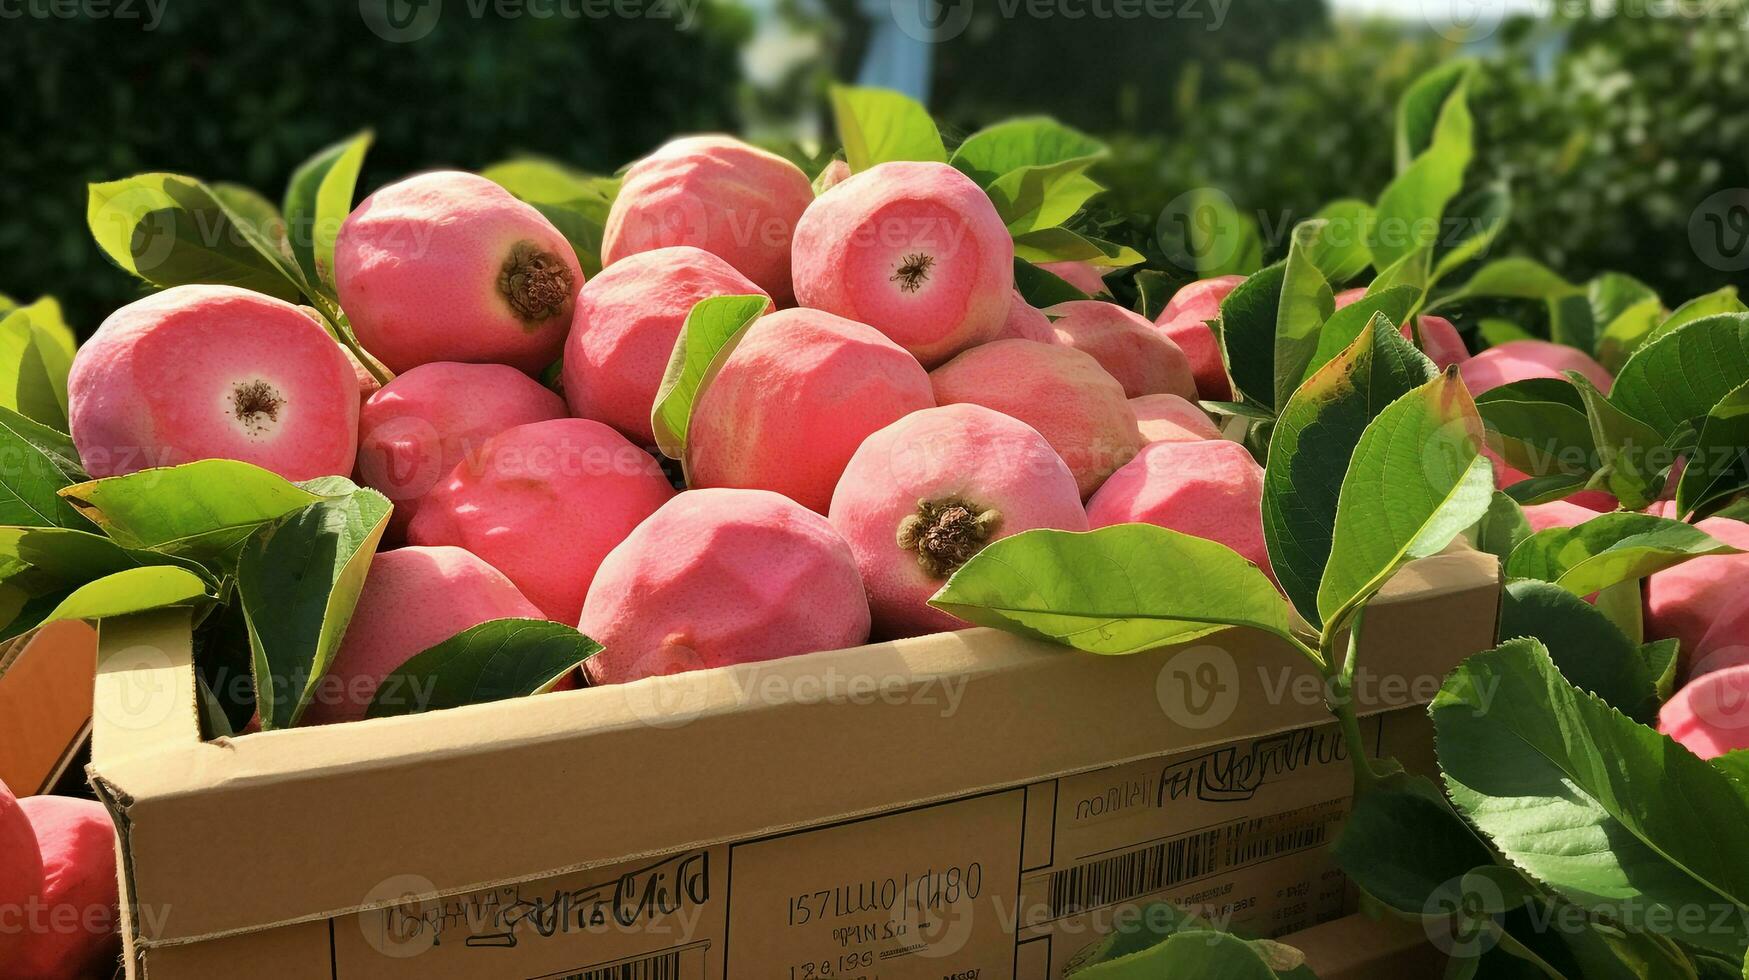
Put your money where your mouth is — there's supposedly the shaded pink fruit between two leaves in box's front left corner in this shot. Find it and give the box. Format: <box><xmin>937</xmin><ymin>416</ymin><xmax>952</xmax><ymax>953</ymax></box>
<box><xmin>301</xmin><ymin>548</ymin><xmax>542</xmax><ymax>725</ymax></box>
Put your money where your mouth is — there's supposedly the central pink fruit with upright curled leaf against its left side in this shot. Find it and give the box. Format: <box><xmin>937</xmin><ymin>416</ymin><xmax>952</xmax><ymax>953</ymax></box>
<box><xmin>686</xmin><ymin>308</ymin><xmax>936</xmax><ymax>515</ymax></box>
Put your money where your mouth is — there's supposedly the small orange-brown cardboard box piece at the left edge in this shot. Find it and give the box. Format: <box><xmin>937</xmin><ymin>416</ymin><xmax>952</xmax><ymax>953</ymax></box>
<box><xmin>0</xmin><ymin>623</ymin><xmax>96</xmax><ymax>796</ymax></box>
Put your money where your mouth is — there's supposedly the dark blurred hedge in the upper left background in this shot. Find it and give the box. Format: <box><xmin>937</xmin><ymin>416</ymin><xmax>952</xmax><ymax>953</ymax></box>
<box><xmin>0</xmin><ymin>0</ymin><xmax>750</xmax><ymax>334</ymax></box>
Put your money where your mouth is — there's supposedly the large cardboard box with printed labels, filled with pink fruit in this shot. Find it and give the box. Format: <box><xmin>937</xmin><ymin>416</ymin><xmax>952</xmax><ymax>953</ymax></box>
<box><xmin>89</xmin><ymin>553</ymin><xmax>1499</xmax><ymax>980</ymax></box>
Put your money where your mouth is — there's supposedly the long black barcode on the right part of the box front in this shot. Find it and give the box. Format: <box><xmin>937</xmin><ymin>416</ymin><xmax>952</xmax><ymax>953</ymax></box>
<box><xmin>1048</xmin><ymin>800</ymin><xmax>1347</xmax><ymax>921</ymax></box>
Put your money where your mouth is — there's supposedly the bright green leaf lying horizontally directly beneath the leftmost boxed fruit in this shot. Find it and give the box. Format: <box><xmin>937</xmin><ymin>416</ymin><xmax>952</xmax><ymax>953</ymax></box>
<box><xmin>61</xmin><ymin>459</ymin><xmax>324</xmax><ymax>560</ymax></box>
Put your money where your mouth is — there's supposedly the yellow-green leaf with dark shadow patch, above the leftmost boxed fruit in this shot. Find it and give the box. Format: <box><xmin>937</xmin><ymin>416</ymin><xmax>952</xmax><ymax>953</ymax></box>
<box><xmin>86</xmin><ymin>173</ymin><xmax>308</xmax><ymax>301</ymax></box>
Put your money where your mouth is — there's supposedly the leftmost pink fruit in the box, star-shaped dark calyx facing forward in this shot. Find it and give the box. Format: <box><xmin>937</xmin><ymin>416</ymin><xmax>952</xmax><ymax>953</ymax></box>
<box><xmin>66</xmin><ymin>285</ymin><xmax>359</xmax><ymax>480</ymax></box>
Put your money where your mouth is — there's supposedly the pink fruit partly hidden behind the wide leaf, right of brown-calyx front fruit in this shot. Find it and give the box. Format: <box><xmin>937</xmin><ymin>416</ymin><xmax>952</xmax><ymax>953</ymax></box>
<box><xmin>1088</xmin><ymin>439</ymin><xmax>1275</xmax><ymax>578</ymax></box>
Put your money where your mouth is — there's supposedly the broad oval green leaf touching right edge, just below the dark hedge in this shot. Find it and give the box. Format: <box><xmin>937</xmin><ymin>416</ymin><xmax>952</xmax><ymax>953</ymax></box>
<box><xmin>1609</xmin><ymin>313</ymin><xmax>1749</xmax><ymax>436</ymax></box>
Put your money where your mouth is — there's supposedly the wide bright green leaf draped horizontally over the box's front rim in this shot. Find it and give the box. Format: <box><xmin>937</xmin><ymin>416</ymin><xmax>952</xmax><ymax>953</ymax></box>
<box><xmin>930</xmin><ymin>523</ymin><xmax>1291</xmax><ymax>655</ymax></box>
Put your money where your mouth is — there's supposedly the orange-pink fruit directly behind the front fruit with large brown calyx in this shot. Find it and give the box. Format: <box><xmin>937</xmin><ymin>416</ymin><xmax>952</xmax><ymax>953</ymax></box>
<box><xmin>929</xmin><ymin>340</ymin><xmax>1142</xmax><ymax>499</ymax></box>
